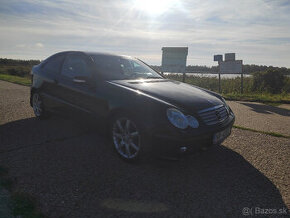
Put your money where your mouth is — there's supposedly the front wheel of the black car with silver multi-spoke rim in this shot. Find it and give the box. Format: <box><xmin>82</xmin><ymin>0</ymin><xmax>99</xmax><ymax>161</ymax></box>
<box><xmin>109</xmin><ymin>114</ymin><xmax>145</xmax><ymax>162</ymax></box>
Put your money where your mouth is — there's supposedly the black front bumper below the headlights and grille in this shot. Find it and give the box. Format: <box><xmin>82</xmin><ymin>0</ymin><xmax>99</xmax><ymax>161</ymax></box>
<box><xmin>151</xmin><ymin>113</ymin><xmax>235</xmax><ymax>156</ymax></box>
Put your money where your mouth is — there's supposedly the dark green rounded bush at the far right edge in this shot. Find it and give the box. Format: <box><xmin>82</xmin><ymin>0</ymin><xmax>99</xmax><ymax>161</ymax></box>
<box><xmin>252</xmin><ymin>69</ymin><xmax>288</xmax><ymax>94</ymax></box>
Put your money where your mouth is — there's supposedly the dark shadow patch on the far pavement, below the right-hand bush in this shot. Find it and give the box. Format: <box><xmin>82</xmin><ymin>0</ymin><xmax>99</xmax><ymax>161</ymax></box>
<box><xmin>240</xmin><ymin>102</ymin><xmax>290</xmax><ymax>117</ymax></box>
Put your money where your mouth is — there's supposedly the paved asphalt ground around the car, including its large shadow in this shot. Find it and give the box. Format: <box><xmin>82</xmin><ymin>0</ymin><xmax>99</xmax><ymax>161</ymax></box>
<box><xmin>0</xmin><ymin>81</ymin><xmax>290</xmax><ymax>217</ymax></box>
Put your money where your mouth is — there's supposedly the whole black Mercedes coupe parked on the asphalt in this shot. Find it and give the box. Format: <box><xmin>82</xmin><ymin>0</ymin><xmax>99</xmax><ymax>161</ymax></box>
<box><xmin>30</xmin><ymin>51</ymin><xmax>235</xmax><ymax>160</ymax></box>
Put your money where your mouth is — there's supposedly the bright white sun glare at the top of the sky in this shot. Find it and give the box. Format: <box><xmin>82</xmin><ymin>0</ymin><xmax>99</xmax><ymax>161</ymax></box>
<box><xmin>133</xmin><ymin>0</ymin><xmax>176</xmax><ymax>16</ymax></box>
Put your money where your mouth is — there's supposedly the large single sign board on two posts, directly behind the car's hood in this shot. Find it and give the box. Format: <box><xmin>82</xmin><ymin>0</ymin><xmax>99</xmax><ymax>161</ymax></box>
<box><xmin>162</xmin><ymin>47</ymin><xmax>188</xmax><ymax>73</ymax></box>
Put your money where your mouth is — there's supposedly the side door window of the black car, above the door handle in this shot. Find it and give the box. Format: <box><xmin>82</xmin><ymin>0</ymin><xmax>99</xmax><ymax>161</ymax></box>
<box><xmin>61</xmin><ymin>54</ymin><xmax>90</xmax><ymax>78</ymax></box>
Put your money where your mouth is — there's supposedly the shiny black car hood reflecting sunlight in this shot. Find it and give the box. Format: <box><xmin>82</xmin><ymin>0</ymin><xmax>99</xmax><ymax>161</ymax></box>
<box><xmin>110</xmin><ymin>79</ymin><xmax>223</xmax><ymax>111</ymax></box>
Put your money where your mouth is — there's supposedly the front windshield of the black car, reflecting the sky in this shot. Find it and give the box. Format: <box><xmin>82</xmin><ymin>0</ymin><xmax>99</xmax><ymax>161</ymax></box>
<box><xmin>92</xmin><ymin>55</ymin><xmax>163</xmax><ymax>80</ymax></box>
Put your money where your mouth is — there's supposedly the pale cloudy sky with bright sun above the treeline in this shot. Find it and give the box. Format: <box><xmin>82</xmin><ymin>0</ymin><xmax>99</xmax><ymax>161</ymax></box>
<box><xmin>0</xmin><ymin>0</ymin><xmax>290</xmax><ymax>67</ymax></box>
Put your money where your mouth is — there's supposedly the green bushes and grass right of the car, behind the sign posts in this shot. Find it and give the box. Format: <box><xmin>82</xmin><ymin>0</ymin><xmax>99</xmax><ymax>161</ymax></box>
<box><xmin>166</xmin><ymin>69</ymin><xmax>290</xmax><ymax>104</ymax></box>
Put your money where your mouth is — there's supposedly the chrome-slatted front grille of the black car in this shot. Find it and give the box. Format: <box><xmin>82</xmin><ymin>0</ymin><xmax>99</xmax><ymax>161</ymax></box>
<box><xmin>198</xmin><ymin>105</ymin><xmax>229</xmax><ymax>125</ymax></box>
